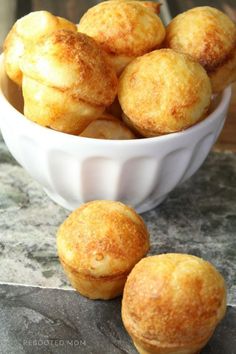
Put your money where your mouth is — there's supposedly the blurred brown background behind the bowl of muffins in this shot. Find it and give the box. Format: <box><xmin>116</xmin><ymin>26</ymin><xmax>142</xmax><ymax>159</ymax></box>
<box><xmin>0</xmin><ymin>0</ymin><xmax>236</xmax><ymax>151</ymax></box>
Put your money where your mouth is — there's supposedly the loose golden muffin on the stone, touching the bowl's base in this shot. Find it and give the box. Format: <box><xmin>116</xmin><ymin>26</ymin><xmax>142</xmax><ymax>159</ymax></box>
<box><xmin>57</xmin><ymin>200</ymin><xmax>149</xmax><ymax>299</ymax></box>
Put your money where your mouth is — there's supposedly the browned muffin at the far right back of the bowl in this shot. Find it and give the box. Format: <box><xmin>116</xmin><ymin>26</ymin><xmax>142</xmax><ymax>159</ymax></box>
<box><xmin>165</xmin><ymin>6</ymin><xmax>236</xmax><ymax>92</ymax></box>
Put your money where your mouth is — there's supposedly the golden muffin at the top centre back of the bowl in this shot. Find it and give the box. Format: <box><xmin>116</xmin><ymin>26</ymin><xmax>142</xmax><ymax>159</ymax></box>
<box><xmin>77</xmin><ymin>1</ymin><xmax>165</xmax><ymax>74</ymax></box>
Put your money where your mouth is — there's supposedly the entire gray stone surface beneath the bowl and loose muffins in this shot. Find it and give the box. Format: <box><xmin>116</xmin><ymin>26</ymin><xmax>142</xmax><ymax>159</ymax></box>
<box><xmin>0</xmin><ymin>133</ymin><xmax>236</xmax><ymax>354</ymax></box>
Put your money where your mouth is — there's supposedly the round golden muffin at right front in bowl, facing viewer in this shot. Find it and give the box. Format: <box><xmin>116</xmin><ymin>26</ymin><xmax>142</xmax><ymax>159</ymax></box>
<box><xmin>118</xmin><ymin>49</ymin><xmax>211</xmax><ymax>137</ymax></box>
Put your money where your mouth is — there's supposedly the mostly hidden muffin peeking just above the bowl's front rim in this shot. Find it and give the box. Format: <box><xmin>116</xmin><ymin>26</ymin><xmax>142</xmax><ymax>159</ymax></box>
<box><xmin>80</xmin><ymin>114</ymin><xmax>135</xmax><ymax>140</ymax></box>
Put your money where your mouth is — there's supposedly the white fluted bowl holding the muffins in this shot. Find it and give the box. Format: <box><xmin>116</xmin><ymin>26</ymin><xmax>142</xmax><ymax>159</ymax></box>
<box><xmin>0</xmin><ymin>53</ymin><xmax>231</xmax><ymax>213</ymax></box>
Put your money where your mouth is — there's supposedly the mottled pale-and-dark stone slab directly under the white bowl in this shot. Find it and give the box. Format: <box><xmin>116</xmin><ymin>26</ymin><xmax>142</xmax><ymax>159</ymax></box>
<box><xmin>0</xmin><ymin>136</ymin><xmax>236</xmax><ymax>304</ymax></box>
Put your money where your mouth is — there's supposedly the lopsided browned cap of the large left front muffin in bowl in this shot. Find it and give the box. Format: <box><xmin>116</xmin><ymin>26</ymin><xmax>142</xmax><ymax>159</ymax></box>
<box><xmin>21</xmin><ymin>30</ymin><xmax>117</xmax><ymax>106</ymax></box>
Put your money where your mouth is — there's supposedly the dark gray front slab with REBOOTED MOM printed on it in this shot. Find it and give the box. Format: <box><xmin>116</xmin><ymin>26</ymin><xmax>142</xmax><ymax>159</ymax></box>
<box><xmin>0</xmin><ymin>285</ymin><xmax>236</xmax><ymax>354</ymax></box>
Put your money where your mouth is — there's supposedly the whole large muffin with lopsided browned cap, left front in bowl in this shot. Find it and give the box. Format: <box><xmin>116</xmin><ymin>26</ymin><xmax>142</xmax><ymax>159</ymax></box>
<box><xmin>21</xmin><ymin>30</ymin><xmax>117</xmax><ymax>134</ymax></box>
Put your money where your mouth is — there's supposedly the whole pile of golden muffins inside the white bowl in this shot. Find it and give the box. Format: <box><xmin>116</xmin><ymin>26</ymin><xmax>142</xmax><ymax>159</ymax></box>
<box><xmin>4</xmin><ymin>0</ymin><xmax>236</xmax><ymax>139</ymax></box>
